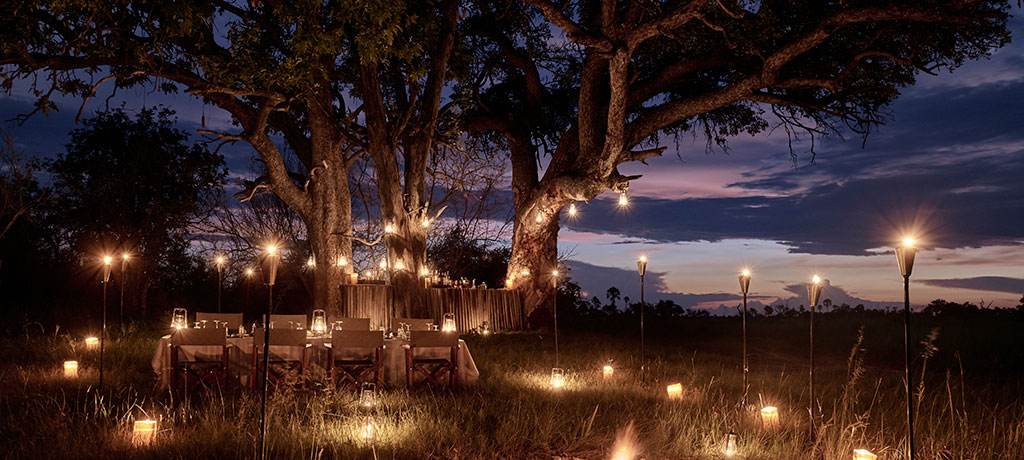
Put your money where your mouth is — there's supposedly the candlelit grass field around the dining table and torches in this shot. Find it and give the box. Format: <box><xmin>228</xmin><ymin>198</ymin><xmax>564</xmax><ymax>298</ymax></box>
<box><xmin>0</xmin><ymin>316</ymin><xmax>1024</xmax><ymax>460</ymax></box>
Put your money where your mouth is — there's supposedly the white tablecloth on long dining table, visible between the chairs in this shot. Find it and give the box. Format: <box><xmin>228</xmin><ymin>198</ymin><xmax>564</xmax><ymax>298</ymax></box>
<box><xmin>151</xmin><ymin>335</ymin><xmax>480</xmax><ymax>388</ymax></box>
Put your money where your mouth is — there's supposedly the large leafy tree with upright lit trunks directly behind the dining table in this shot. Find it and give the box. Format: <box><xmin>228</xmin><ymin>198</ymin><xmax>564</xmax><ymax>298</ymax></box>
<box><xmin>0</xmin><ymin>0</ymin><xmax>458</xmax><ymax>308</ymax></box>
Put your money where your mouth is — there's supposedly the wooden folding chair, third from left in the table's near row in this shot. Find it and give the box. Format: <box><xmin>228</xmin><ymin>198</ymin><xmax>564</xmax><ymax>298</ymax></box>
<box><xmin>327</xmin><ymin>330</ymin><xmax>384</xmax><ymax>388</ymax></box>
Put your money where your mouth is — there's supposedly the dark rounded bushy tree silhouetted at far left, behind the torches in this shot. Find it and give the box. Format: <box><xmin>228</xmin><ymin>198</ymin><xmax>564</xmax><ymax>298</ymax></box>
<box><xmin>47</xmin><ymin>109</ymin><xmax>227</xmax><ymax>316</ymax></box>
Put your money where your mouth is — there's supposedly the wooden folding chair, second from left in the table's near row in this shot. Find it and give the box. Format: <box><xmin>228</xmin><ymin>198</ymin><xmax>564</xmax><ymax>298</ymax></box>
<box><xmin>252</xmin><ymin>328</ymin><xmax>310</xmax><ymax>391</ymax></box>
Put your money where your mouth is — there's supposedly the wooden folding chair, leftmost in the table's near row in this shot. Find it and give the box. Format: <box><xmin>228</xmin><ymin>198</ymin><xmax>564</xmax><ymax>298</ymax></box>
<box><xmin>170</xmin><ymin>328</ymin><xmax>227</xmax><ymax>391</ymax></box>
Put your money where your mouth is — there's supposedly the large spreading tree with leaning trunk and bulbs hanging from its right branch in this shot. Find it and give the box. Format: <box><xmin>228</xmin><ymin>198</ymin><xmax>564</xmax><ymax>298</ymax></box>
<box><xmin>463</xmin><ymin>0</ymin><xmax>1009</xmax><ymax>307</ymax></box>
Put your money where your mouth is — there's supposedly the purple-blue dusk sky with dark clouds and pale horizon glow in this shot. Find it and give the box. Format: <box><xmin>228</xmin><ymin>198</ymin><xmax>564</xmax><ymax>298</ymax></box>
<box><xmin>0</xmin><ymin>17</ymin><xmax>1024</xmax><ymax>315</ymax></box>
